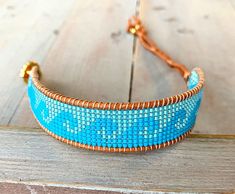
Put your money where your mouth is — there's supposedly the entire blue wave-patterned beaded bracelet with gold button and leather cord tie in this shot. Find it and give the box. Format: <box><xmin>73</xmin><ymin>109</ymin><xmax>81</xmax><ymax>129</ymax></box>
<box><xmin>21</xmin><ymin>17</ymin><xmax>204</xmax><ymax>152</ymax></box>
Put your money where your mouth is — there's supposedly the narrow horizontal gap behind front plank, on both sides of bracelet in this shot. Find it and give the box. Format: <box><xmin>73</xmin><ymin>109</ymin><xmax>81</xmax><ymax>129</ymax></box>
<box><xmin>0</xmin><ymin>125</ymin><xmax>235</xmax><ymax>139</ymax></box>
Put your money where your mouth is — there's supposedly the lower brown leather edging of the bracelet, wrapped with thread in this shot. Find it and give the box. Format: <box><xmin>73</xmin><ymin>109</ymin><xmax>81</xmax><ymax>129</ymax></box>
<box><xmin>34</xmin><ymin>116</ymin><xmax>192</xmax><ymax>152</ymax></box>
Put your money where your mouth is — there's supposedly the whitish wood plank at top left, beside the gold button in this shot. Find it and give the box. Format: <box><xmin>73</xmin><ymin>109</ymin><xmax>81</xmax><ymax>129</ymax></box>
<box><xmin>0</xmin><ymin>0</ymin><xmax>74</xmax><ymax>125</ymax></box>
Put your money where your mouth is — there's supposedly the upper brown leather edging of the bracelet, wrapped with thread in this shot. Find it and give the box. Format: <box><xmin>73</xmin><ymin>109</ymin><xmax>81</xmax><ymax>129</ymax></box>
<box><xmin>30</xmin><ymin>67</ymin><xmax>205</xmax><ymax>110</ymax></box>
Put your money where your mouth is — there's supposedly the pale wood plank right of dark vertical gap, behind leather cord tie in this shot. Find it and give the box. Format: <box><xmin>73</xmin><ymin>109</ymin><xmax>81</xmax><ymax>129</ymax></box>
<box><xmin>132</xmin><ymin>0</ymin><xmax>235</xmax><ymax>134</ymax></box>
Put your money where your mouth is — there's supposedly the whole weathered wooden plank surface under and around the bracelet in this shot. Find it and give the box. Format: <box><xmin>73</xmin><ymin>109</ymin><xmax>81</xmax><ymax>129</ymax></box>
<box><xmin>0</xmin><ymin>0</ymin><xmax>235</xmax><ymax>193</ymax></box>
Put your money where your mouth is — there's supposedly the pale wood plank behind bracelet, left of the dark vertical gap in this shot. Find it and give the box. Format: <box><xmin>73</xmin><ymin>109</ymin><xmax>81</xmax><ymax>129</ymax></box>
<box><xmin>11</xmin><ymin>0</ymin><xmax>136</xmax><ymax>127</ymax></box>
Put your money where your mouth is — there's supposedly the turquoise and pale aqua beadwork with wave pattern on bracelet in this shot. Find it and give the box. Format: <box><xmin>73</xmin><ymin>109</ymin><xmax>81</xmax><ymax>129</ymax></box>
<box><xmin>28</xmin><ymin>68</ymin><xmax>203</xmax><ymax>151</ymax></box>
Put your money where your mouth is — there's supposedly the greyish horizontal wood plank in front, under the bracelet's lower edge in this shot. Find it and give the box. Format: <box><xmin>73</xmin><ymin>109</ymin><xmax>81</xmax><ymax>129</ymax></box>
<box><xmin>0</xmin><ymin>128</ymin><xmax>235</xmax><ymax>192</ymax></box>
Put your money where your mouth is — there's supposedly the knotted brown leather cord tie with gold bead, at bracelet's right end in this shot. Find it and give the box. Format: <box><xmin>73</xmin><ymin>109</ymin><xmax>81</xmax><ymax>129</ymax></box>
<box><xmin>127</xmin><ymin>16</ymin><xmax>190</xmax><ymax>81</ymax></box>
